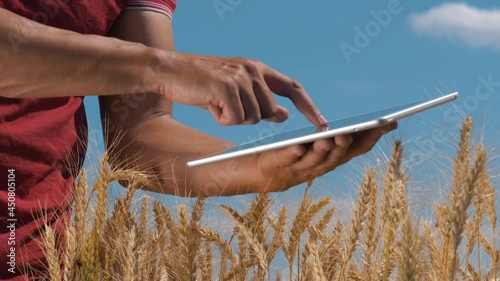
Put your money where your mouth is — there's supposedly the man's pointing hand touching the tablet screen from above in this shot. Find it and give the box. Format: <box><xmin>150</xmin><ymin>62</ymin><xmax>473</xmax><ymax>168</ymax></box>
<box><xmin>157</xmin><ymin>53</ymin><xmax>326</xmax><ymax>126</ymax></box>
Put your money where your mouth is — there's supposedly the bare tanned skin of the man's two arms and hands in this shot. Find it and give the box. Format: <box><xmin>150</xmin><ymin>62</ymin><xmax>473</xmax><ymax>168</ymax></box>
<box><xmin>0</xmin><ymin>9</ymin><xmax>397</xmax><ymax>196</ymax></box>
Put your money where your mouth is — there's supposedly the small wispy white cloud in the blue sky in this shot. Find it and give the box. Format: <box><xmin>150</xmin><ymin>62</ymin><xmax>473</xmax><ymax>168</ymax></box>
<box><xmin>410</xmin><ymin>3</ymin><xmax>500</xmax><ymax>50</ymax></box>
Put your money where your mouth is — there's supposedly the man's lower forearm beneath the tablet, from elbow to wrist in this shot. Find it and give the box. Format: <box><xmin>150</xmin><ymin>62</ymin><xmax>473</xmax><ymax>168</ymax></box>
<box><xmin>115</xmin><ymin>116</ymin><xmax>262</xmax><ymax>196</ymax></box>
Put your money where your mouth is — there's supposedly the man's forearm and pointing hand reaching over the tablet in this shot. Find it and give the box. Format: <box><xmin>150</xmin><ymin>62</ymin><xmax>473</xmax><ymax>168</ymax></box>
<box><xmin>0</xmin><ymin>8</ymin><xmax>326</xmax><ymax>126</ymax></box>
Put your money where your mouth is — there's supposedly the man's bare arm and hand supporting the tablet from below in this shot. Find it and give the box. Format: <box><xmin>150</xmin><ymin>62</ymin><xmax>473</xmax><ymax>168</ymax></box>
<box><xmin>100</xmin><ymin>11</ymin><xmax>395</xmax><ymax>196</ymax></box>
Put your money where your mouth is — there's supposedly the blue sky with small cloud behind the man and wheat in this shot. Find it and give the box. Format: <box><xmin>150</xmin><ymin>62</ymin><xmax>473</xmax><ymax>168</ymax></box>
<box><xmin>85</xmin><ymin>0</ymin><xmax>500</xmax><ymax>213</ymax></box>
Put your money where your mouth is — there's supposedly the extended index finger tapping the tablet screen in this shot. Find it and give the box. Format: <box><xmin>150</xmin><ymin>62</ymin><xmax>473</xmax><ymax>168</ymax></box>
<box><xmin>263</xmin><ymin>65</ymin><xmax>327</xmax><ymax>126</ymax></box>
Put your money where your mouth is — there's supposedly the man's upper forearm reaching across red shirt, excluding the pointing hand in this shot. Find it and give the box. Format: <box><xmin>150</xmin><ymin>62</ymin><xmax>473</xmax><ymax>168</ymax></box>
<box><xmin>0</xmin><ymin>8</ymin><xmax>162</xmax><ymax>98</ymax></box>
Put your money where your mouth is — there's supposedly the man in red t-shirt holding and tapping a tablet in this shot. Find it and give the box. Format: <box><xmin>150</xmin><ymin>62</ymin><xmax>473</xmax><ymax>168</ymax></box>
<box><xmin>0</xmin><ymin>0</ymin><xmax>396</xmax><ymax>280</ymax></box>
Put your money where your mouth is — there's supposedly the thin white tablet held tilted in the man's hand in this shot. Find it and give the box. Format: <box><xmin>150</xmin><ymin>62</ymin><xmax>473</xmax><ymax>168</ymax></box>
<box><xmin>187</xmin><ymin>93</ymin><xmax>458</xmax><ymax>167</ymax></box>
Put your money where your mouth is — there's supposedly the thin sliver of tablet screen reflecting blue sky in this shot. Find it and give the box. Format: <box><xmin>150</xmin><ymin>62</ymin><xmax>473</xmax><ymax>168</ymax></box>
<box><xmin>224</xmin><ymin>101</ymin><xmax>422</xmax><ymax>153</ymax></box>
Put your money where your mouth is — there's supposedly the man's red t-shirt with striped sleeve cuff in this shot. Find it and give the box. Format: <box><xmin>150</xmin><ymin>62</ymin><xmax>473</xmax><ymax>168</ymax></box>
<box><xmin>0</xmin><ymin>0</ymin><xmax>176</xmax><ymax>280</ymax></box>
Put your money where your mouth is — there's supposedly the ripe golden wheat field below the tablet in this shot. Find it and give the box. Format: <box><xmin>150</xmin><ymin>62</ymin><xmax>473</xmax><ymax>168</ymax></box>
<box><xmin>30</xmin><ymin>117</ymin><xmax>500</xmax><ymax>281</ymax></box>
